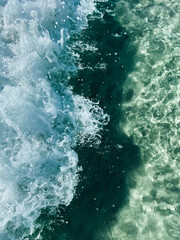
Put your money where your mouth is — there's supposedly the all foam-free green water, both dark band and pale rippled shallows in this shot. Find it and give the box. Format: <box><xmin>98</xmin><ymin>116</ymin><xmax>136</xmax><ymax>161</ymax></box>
<box><xmin>35</xmin><ymin>0</ymin><xmax>180</xmax><ymax>240</ymax></box>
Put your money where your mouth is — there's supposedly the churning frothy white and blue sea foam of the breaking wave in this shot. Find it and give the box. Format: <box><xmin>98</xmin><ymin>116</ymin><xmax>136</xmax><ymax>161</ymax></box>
<box><xmin>0</xmin><ymin>0</ymin><xmax>107</xmax><ymax>240</ymax></box>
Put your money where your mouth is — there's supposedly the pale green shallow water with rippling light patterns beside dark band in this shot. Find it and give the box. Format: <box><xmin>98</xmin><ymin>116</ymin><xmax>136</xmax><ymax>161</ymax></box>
<box><xmin>108</xmin><ymin>0</ymin><xmax>180</xmax><ymax>240</ymax></box>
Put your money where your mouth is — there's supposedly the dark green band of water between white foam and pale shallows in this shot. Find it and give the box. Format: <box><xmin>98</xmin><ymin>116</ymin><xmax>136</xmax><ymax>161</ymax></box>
<box><xmin>35</xmin><ymin>2</ymin><xmax>140</xmax><ymax>240</ymax></box>
